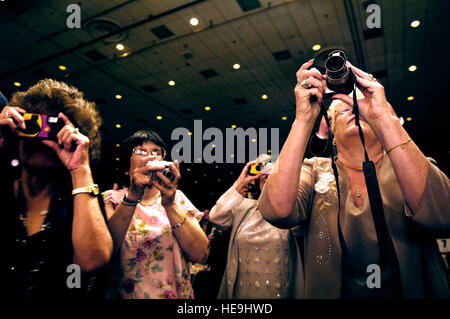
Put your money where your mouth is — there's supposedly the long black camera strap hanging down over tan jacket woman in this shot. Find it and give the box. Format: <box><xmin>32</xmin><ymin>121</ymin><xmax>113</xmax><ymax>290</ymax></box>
<box><xmin>321</xmin><ymin>72</ymin><xmax>390</xmax><ymax>270</ymax></box>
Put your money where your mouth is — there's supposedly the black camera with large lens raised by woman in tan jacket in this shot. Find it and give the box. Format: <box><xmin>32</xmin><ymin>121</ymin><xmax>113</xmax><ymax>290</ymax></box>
<box><xmin>325</xmin><ymin>50</ymin><xmax>355</xmax><ymax>95</ymax></box>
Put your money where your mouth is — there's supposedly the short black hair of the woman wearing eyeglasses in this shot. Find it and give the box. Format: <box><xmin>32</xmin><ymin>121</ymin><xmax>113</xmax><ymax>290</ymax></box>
<box><xmin>120</xmin><ymin>130</ymin><xmax>167</xmax><ymax>172</ymax></box>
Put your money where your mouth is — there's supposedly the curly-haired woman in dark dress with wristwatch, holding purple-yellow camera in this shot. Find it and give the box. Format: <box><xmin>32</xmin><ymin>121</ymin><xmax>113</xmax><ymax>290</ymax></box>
<box><xmin>0</xmin><ymin>79</ymin><xmax>112</xmax><ymax>300</ymax></box>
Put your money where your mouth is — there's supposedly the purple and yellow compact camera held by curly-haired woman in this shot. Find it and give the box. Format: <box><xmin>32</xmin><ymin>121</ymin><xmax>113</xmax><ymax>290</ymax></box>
<box><xmin>17</xmin><ymin>113</ymin><xmax>64</xmax><ymax>141</ymax></box>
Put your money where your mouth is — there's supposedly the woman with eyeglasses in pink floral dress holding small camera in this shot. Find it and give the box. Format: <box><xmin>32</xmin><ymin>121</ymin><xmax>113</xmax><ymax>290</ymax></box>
<box><xmin>108</xmin><ymin>130</ymin><xmax>208</xmax><ymax>299</ymax></box>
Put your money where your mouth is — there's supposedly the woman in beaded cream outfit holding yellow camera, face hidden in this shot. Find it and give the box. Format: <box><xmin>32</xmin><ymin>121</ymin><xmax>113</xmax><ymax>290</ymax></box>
<box><xmin>209</xmin><ymin>155</ymin><xmax>303</xmax><ymax>299</ymax></box>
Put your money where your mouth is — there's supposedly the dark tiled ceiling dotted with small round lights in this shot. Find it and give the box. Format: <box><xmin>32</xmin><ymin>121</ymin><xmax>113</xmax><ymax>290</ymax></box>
<box><xmin>0</xmin><ymin>0</ymin><xmax>450</xmax><ymax>209</ymax></box>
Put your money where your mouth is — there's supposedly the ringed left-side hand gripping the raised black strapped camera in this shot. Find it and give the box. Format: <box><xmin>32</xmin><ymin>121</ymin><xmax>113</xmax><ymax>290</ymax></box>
<box><xmin>294</xmin><ymin>59</ymin><xmax>325</xmax><ymax>122</ymax></box>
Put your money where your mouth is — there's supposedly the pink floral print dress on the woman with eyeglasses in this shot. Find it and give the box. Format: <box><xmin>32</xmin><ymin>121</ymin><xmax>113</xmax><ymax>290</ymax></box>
<box><xmin>119</xmin><ymin>190</ymin><xmax>203</xmax><ymax>299</ymax></box>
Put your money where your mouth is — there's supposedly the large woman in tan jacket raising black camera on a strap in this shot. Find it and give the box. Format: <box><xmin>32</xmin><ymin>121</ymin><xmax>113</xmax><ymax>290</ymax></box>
<box><xmin>259</xmin><ymin>60</ymin><xmax>450</xmax><ymax>298</ymax></box>
